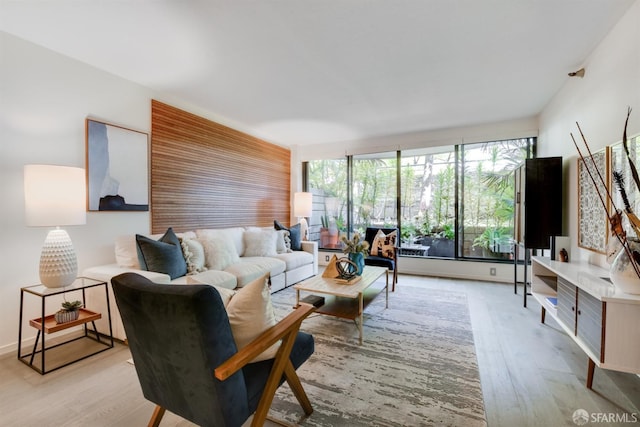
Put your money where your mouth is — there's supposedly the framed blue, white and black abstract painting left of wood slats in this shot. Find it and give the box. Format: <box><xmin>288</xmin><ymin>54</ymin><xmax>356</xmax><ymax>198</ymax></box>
<box><xmin>85</xmin><ymin>119</ymin><xmax>149</xmax><ymax>211</ymax></box>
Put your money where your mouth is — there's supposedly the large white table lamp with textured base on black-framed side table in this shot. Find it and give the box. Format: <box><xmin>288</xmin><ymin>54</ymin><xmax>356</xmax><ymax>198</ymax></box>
<box><xmin>24</xmin><ymin>165</ymin><xmax>87</xmax><ymax>288</ymax></box>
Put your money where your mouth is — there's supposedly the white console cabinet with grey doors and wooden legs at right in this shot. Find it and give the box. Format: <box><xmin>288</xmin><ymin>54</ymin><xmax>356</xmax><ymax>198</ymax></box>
<box><xmin>531</xmin><ymin>257</ymin><xmax>640</xmax><ymax>388</ymax></box>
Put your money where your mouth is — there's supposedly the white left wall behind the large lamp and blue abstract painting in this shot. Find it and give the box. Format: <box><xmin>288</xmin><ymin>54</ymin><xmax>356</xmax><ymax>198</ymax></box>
<box><xmin>0</xmin><ymin>32</ymin><xmax>235</xmax><ymax>354</ymax></box>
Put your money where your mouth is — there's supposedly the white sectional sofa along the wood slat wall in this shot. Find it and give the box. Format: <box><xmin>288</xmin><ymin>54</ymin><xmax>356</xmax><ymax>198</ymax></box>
<box><xmin>82</xmin><ymin>227</ymin><xmax>318</xmax><ymax>340</ymax></box>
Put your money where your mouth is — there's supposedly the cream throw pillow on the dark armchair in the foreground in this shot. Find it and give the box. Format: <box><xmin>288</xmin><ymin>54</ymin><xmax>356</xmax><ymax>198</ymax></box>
<box><xmin>227</xmin><ymin>273</ymin><xmax>280</xmax><ymax>362</ymax></box>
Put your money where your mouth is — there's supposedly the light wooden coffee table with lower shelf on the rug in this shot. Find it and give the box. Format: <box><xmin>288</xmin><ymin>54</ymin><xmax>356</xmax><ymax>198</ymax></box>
<box><xmin>293</xmin><ymin>266</ymin><xmax>389</xmax><ymax>344</ymax></box>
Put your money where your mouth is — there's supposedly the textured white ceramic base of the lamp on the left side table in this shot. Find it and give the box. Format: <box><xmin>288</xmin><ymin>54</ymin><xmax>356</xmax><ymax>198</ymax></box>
<box><xmin>40</xmin><ymin>228</ymin><xmax>78</xmax><ymax>288</ymax></box>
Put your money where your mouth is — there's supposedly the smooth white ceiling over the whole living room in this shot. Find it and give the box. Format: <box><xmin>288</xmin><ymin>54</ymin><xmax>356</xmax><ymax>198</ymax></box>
<box><xmin>0</xmin><ymin>0</ymin><xmax>634</xmax><ymax>145</ymax></box>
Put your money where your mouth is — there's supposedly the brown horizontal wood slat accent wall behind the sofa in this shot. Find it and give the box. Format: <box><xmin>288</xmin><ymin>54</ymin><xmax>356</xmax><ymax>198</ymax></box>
<box><xmin>151</xmin><ymin>100</ymin><xmax>291</xmax><ymax>233</ymax></box>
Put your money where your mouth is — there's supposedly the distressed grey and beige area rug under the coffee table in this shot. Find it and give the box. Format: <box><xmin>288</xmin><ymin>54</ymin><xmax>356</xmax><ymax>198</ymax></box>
<box><xmin>271</xmin><ymin>284</ymin><xmax>486</xmax><ymax>427</ymax></box>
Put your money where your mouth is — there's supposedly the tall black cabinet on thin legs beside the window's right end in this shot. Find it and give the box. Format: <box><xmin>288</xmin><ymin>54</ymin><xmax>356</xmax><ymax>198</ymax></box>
<box><xmin>514</xmin><ymin>157</ymin><xmax>562</xmax><ymax>307</ymax></box>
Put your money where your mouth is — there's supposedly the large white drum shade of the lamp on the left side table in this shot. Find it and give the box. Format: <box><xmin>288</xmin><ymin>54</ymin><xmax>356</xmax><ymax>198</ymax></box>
<box><xmin>24</xmin><ymin>165</ymin><xmax>87</xmax><ymax>226</ymax></box>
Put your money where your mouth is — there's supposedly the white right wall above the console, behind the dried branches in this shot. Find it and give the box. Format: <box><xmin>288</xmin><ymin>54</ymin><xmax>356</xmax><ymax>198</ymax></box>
<box><xmin>538</xmin><ymin>2</ymin><xmax>640</xmax><ymax>266</ymax></box>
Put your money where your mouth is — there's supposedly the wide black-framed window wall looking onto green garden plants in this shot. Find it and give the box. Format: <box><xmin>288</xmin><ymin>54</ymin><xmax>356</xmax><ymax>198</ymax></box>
<box><xmin>307</xmin><ymin>138</ymin><xmax>535</xmax><ymax>260</ymax></box>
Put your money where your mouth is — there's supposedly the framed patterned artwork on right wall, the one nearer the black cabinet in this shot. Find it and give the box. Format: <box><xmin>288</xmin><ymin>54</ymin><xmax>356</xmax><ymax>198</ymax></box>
<box><xmin>578</xmin><ymin>147</ymin><xmax>609</xmax><ymax>254</ymax></box>
